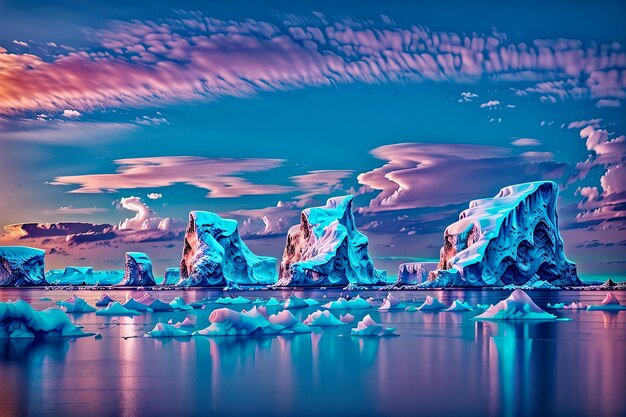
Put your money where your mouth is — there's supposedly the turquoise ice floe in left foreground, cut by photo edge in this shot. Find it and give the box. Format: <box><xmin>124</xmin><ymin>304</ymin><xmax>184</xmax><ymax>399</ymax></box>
<box><xmin>0</xmin><ymin>299</ymin><xmax>93</xmax><ymax>339</ymax></box>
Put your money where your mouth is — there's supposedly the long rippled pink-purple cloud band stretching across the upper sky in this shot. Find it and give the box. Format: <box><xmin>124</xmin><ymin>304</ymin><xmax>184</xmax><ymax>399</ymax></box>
<box><xmin>0</xmin><ymin>12</ymin><xmax>626</xmax><ymax>114</ymax></box>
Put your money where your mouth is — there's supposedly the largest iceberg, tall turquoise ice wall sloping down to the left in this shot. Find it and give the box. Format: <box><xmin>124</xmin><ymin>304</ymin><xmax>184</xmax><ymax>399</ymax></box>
<box><xmin>423</xmin><ymin>181</ymin><xmax>581</xmax><ymax>287</ymax></box>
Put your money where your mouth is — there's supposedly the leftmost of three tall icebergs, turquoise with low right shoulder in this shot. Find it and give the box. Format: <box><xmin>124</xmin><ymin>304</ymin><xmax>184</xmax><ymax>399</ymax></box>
<box><xmin>179</xmin><ymin>211</ymin><xmax>276</xmax><ymax>286</ymax></box>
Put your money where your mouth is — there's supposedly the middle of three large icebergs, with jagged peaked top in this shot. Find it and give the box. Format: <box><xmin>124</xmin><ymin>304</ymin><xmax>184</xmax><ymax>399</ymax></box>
<box><xmin>277</xmin><ymin>196</ymin><xmax>385</xmax><ymax>286</ymax></box>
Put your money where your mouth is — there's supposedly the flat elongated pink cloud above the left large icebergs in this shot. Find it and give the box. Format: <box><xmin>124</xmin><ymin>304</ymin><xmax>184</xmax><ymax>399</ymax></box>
<box><xmin>50</xmin><ymin>156</ymin><xmax>292</xmax><ymax>198</ymax></box>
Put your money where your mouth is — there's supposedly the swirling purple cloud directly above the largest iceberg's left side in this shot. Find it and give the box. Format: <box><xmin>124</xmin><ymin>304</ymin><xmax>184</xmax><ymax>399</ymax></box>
<box><xmin>358</xmin><ymin>143</ymin><xmax>566</xmax><ymax>213</ymax></box>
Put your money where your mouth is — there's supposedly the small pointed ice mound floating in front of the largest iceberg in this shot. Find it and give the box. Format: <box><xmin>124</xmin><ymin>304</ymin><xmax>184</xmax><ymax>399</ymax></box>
<box><xmin>474</xmin><ymin>290</ymin><xmax>556</xmax><ymax>320</ymax></box>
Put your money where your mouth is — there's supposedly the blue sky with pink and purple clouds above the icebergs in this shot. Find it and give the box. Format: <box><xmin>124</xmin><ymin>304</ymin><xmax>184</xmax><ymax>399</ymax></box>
<box><xmin>0</xmin><ymin>0</ymin><xmax>626</xmax><ymax>281</ymax></box>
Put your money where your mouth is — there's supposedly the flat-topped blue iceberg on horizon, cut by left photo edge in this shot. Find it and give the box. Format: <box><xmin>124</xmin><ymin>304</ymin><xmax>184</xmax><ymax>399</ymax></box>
<box><xmin>0</xmin><ymin>246</ymin><xmax>46</xmax><ymax>286</ymax></box>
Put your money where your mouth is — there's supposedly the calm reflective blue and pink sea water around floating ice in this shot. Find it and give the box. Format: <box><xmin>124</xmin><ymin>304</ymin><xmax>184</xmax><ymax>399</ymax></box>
<box><xmin>0</xmin><ymin>289</ymin><xmax>626</xmax><ymax>417</ymax></box>
